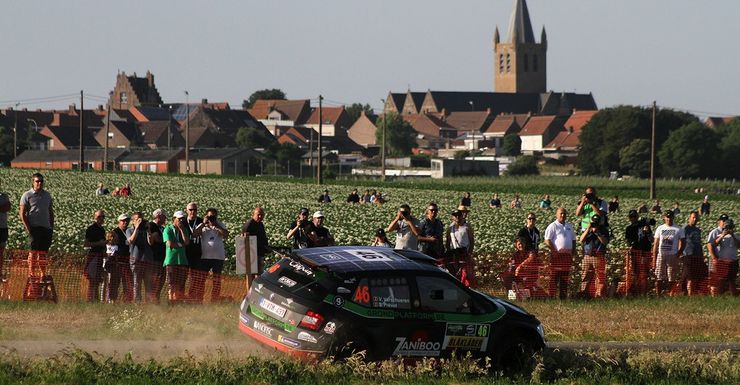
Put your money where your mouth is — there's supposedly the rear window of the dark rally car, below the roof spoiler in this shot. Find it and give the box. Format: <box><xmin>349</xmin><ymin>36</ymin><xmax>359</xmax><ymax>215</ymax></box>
<box><xmin>262</xmin><ymin>258</ymin><xmax>336</xmax><ymax>301</ymax></box>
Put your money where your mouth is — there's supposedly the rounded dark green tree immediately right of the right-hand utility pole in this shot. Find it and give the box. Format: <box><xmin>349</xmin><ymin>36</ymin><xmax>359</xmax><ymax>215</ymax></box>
<box><xmin>658</xmin><ymin>122</ymin><xmax>720</xmax><ymax>178</ymax></box>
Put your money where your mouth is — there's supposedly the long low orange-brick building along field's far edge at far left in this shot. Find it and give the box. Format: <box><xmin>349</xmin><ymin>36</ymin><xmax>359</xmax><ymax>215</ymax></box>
<box><xmin>10</xmin><ymin>148</ymin><xmax>127</xmax><ymax>170</ymax></box>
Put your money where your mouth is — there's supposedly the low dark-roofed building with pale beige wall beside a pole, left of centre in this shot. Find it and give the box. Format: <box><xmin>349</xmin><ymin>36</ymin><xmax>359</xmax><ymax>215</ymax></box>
<box><xmin>178</xmin><ymin>148</ymin><xmax>264</xmax><ymax>175</ymax></box>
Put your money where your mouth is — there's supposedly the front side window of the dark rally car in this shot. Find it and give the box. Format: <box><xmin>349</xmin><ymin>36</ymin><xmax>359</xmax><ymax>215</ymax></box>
<box><xmin>416</xmin><ymin>277</ymin><xmax>471</xmax><ymax>313</ymax></box>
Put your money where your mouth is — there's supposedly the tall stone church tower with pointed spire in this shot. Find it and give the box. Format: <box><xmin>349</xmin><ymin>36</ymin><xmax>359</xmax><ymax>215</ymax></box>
<box><xmin>493</xmin><ymin>0</ymin><xmax>547</xmax><ymax>93</ymax></box>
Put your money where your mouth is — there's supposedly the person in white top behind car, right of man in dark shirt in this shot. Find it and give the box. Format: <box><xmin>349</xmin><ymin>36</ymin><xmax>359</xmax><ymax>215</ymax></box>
<box><xmin>445</xmin><ymin>210</ymin><xmax>475</xmax><ymax>286</ymax></box>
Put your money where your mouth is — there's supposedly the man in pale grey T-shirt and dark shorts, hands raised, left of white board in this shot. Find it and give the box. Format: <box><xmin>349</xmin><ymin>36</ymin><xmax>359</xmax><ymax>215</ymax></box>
<box><xmin>196</xmin><ymin>208</ymin><xmax>229</xmax><ymax>302</ymax></box>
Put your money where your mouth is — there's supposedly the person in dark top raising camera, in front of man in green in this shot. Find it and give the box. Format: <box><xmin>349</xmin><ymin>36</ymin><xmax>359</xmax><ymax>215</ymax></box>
<box><xmin>580</xmin><ymin>215</ymin><xmax>609</xmax><ymax>298</ymax></box>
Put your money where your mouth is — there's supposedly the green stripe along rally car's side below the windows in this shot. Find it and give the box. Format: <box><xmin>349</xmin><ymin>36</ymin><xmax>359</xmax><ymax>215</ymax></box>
<box><xmin>324</xmin><ymin>294</ymin><xmax>506</xmax><ymax>323</ymax></box>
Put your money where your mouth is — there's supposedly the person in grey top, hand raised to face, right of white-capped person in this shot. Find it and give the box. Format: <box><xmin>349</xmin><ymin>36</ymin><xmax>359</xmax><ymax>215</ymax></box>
<box><xmin>126</xmin><ymin>211</ymin><xmax>154</xmax><ymax>303</ymax></box>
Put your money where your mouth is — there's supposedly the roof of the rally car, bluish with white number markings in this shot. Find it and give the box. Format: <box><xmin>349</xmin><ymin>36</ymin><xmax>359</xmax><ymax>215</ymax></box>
<box><xmin>293</xmin><ymin>246</ymin><xmax>439</xmax><ymax>273</ymax></box>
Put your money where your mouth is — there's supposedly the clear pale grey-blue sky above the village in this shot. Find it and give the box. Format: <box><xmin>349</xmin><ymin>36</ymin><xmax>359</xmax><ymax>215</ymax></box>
<box><xmin>0</xmin><ymin>0</ymin><xmax>740</xmax><ymax>117</ymax></box>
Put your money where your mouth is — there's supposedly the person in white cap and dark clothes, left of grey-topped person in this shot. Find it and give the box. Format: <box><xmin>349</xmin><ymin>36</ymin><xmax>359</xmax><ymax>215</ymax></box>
<box><xmin>107</xmin><ymin>213</ymin><xmax>134</xmax><ymax>302</ymax></box>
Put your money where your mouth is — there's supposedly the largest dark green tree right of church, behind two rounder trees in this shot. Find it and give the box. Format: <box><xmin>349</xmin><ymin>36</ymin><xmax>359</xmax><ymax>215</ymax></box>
<box><xmin>578</xmin><ymin>106</ymin><xmax>699</xmax><ymax>175</ymax></box>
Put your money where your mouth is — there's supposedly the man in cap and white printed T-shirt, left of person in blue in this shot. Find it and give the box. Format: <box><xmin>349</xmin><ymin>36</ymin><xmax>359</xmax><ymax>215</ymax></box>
<box><xmin>652</xmin><ymin>210</ymin><xmax>683</xmax><ymax>296</ymax></box>
